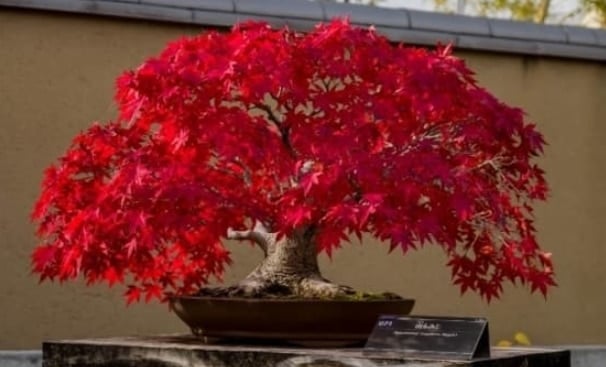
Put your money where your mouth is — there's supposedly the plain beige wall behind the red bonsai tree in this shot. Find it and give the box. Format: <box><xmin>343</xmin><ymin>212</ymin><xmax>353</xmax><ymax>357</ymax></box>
<box><xmin>0</xmin><ymin>9</ymin><xmax>606</xmax><ymax>349</ymax></box>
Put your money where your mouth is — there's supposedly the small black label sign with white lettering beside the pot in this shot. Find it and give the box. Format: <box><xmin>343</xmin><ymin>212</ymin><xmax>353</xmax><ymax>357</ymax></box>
<box><xmin>364</xmin><ymin>315</ymin><xmax>490</xmax><ymax>360</ymax></box>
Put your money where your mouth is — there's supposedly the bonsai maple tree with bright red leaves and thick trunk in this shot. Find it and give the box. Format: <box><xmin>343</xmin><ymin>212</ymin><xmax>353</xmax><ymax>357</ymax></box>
<box><xmin>32</xmin><ymin>20</ymin><xmax>554</xmax><ymax>302</ymax></box>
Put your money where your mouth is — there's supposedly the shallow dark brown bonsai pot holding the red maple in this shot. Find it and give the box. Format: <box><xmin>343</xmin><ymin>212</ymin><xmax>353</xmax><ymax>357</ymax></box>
<box><xmin>171</xmin><ymin>297</ymin><xmax>414</xmax><ymax>346</ymax></box>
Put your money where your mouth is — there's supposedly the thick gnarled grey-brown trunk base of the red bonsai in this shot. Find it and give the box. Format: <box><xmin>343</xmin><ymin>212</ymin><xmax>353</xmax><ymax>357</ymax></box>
<box><xmin>229</xmin><ymin>224</ymin><xmax>355</xmax><ymax>297</ymax></box>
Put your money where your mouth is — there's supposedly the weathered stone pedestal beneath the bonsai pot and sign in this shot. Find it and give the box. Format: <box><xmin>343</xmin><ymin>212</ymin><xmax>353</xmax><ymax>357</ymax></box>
<box><xmin>43</xmin><ymin>336</ymin><xmax>570</xmax><ymax>367</ymax></box>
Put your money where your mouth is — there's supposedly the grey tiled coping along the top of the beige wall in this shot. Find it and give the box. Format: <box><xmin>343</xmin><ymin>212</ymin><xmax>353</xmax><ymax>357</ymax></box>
<box><xmin>0</xmin><ymin>0</ymin><xmax>606</xmax><ymax>61</ymax></box>
